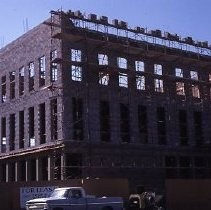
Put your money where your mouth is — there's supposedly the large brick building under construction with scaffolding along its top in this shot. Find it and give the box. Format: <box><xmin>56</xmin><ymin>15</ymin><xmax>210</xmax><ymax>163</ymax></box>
<box><xmin>0</xmin><ymin>11</ymin><xmax>211</xmax><ymax>193</ymax></box>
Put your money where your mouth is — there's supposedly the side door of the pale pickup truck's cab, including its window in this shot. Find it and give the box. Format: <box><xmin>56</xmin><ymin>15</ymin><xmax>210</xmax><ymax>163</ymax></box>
<box><xmin>68</xmin><ymin>189</ymin><xmax>86</xmax><ymax>210</ymax></box>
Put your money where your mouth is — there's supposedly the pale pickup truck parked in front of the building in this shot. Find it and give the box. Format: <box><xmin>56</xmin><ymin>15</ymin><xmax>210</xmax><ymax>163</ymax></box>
<box><xmin>26</xmin><ymin>187</ymin><xmax>123</xmax><ymax>210</ymax></box>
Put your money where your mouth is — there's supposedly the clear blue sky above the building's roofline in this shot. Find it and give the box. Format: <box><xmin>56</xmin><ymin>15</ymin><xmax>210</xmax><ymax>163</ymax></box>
<box><xmin>0</xmin><ymin>0</ymin><xmax>211</xmax><ymax>47</ymax></box>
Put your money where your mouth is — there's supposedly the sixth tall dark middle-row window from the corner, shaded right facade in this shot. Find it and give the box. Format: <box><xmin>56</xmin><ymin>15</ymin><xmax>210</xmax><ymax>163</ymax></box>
<box><xmin>178</xmin><ymin>110</ymin><xmax>188</xmax><ymax>146</ymax></box>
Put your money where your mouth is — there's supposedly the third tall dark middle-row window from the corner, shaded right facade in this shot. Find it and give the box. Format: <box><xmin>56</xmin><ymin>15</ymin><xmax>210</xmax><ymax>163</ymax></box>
<box><xmin>120</xmin><ymin>104</ymin><xmax>130</xmax><ymax>143</ymax></box>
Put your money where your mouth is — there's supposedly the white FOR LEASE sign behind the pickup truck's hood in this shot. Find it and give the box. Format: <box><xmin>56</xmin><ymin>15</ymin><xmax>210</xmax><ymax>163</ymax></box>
<box><xmin>20</xmin><ymin>186</ymin><xmax>57</xmax><ymax>208</ymax></box>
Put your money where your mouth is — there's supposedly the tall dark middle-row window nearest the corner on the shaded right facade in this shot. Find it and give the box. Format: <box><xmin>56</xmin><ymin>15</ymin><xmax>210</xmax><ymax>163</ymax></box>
<box><xmin>72</xmin><ymin>97</ymin><xmax>84</xmax><ymax>140</ymax></box>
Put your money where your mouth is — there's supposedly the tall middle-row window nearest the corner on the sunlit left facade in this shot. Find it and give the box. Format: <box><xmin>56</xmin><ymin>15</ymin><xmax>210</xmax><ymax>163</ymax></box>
<box><xmin>50</xmin><ymin>98</ymin><xmax>58</xmax><ymax>141</ymax></box>
